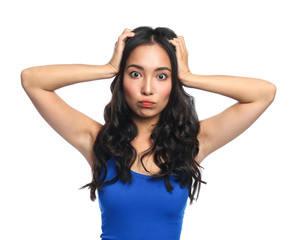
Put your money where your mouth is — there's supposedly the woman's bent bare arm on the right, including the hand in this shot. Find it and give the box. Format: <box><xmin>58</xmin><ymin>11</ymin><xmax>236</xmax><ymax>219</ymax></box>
<box><xmin>170</xmin><ymin>37</ymin><xmax>276</xmax><ymax>163</ymax></box>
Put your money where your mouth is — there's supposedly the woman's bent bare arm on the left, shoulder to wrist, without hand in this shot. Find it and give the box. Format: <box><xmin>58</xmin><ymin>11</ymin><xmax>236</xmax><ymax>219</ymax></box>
<box><xmin>21</xmin><ymin>64</ymin><xmax>115</xmax><ymax>165</ymax></box>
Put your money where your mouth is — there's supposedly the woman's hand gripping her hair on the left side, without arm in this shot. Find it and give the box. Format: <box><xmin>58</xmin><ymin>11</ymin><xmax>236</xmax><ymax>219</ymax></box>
<box><xmin>107</xmin><ymin>28</ymin><xmax>135</xmax><ymax>75</ymax></box>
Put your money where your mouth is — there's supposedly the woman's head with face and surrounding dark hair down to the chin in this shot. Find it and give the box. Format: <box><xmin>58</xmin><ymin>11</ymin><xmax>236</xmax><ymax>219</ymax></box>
<box><xmin>111</xmin><ymin>27</ymin><xmax>182</xmax><ymax>121</ymax></box>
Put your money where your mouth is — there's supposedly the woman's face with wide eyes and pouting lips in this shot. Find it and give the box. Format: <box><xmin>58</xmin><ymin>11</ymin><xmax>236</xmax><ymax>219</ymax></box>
<box><xmin>123</xmin><ymin>44</ymin><xmax>172</xmax><ymax>120</ymax></box>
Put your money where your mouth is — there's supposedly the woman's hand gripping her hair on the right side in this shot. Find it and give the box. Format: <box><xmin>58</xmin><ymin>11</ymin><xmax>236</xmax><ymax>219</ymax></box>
<box><xmin>168</xmin><ymin>36</ymin><xmax>191</xmax><ymax>84</ymax></box>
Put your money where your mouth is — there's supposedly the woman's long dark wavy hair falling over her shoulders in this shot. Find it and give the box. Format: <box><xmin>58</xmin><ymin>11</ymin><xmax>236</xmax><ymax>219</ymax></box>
<box><xmin>81</xmin><ymin>27</ymin><xmax>205</xmax><ymax>204</ymax></box>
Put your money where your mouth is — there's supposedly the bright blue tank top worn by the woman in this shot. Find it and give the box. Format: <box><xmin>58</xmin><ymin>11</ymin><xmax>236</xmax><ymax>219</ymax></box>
<box><xmin>97</xmin><ymin>157</ymin><xmax>188</xmax><ymax>240</ymax></box>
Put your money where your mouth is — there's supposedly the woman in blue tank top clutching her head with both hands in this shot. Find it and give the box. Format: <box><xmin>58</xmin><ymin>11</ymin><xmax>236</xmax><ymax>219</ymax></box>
<box><xmin>21</xmin><ymin>27</ymin><xmax>276</xmax><ymax>240</ymax></box>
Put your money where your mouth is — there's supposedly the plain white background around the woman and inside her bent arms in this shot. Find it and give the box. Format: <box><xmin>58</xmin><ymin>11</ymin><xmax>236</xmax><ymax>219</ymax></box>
<box><xmin>0</xmin><ymin>0</ymin><xmax>299</xmax><ymax>240</ymax></box>
